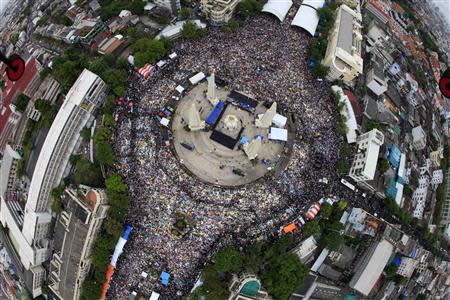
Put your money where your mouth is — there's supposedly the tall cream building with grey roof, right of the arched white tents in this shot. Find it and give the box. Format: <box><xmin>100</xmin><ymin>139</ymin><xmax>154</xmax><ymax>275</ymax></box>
<box><xmin>322</xmin><ymin>5</ymin><xmax>363</xmax><ymax>82</ymax></box>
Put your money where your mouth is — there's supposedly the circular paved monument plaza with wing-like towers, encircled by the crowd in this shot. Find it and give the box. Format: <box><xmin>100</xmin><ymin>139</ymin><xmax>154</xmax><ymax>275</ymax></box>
<box><xmin>171</xmin><ymin>72</ymin><xmax>294</xmax><ymax>187</ymax></box>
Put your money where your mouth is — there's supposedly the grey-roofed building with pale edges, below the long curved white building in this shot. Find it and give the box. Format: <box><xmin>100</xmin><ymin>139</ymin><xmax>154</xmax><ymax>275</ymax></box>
<box><xmin>48</xmin><ymin>186</ymin><xmax>109</xmax><ymax>300</ymax></box>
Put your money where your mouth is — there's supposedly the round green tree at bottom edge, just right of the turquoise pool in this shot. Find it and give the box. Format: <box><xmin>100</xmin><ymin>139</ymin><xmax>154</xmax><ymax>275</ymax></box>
<box><xmin>261</xmin><ymin>253</ymin><xmax>309</xmax><ymax>300</ymax></box>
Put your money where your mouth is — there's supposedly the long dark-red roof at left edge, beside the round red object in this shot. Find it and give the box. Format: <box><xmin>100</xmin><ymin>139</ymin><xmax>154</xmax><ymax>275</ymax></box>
<box><xmin>0</xmin><ymin>57</ymin><xmax>37</xmax><ymax>150</ymax></box>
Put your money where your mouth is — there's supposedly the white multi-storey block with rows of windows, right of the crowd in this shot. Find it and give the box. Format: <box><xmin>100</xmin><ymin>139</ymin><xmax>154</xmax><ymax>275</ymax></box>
<box><xmin>349</xmin><ymin>129</ymin><xmax>384</xmax><ymax>182</ymax></box>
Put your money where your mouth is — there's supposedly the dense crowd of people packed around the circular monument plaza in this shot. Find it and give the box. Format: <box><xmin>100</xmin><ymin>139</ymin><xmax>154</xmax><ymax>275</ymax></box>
<box><xmin>108</xmin><ymin>16</ymin><xmax>352</xmax><ymax>299</ymax></box>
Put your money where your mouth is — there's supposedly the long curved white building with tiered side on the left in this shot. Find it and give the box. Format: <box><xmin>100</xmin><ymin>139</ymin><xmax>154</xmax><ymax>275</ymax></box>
<box><xmin>0</xmin><ymin>69</ymin><xmax>105</xmax><ymax>297</ymax></box>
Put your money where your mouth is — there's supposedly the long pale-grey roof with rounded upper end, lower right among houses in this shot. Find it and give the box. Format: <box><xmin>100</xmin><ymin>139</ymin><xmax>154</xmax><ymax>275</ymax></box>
<box><xmin>349</xmin><ymin>239</ymin><xmax>394</xmax><ymax>296</ymax></box>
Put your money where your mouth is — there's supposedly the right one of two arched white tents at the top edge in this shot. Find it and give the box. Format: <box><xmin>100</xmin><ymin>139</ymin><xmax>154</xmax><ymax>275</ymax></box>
<box><xmin>291</xmin><ymin>0</ymin><xmax>325</xmax><ymax>36</ymax></box>
